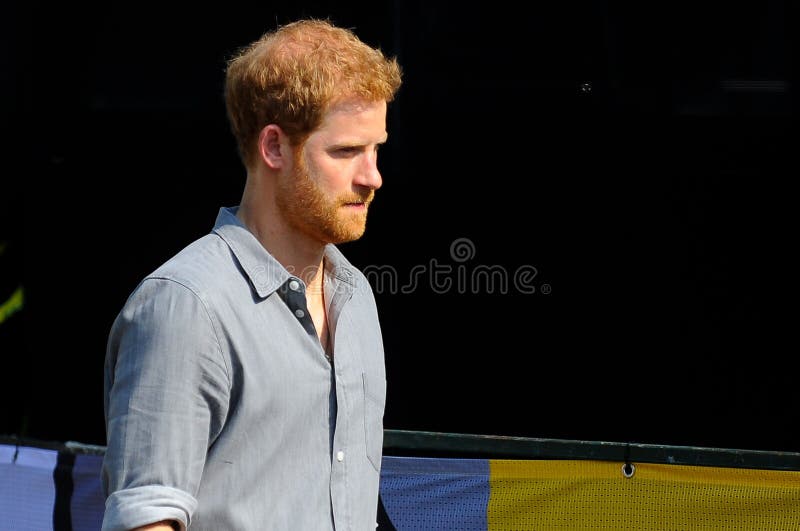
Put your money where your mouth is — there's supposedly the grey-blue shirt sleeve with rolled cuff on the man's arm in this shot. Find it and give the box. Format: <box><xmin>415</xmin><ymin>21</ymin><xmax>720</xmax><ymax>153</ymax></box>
<box><xmin>102</xmin><ymin>278</ymin><xmax>230</xmax><ymax>530</ymax></box>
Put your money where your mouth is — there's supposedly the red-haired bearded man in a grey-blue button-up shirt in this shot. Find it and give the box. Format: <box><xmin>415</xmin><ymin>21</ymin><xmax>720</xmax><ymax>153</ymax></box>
<box><xmin>103</xmin><ymin>20</ymin><xmax>401</xmax><ymax>531</ymax></box>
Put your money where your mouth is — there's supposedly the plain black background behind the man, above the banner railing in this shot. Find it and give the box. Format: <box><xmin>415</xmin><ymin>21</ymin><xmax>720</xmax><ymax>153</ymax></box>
<box><xmin>0</xmin><ymin>0</ymin><xmax>800</xmax><ymax>451</ymax></box>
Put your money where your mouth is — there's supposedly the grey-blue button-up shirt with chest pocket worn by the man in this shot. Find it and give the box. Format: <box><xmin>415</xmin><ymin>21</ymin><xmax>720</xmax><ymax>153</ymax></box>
<box><xmin>102</xmin><ymin>208</ymin><xmax>386</xmax><ymax>531</ymax></box>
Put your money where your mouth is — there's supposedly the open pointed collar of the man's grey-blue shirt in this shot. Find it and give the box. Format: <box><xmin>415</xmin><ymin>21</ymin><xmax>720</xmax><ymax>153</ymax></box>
<box><xmin>213</xmin><ymin>206</ymin><xmax>357</xmax><ymax>298</ymax></box>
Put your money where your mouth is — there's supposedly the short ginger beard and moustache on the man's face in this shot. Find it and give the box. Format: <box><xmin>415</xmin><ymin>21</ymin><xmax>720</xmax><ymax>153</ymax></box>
<box><xmin>276</xmin><ymin>150</ymin><xmax>375</xmax><ymax>244</ymax></box>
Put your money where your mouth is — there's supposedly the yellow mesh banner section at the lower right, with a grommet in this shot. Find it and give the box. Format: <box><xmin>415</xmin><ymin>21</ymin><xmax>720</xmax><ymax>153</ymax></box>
<box><xmin>487</xmin><ymin>459</ymin><xmax>800</xmax><ymax>531</ymax></box>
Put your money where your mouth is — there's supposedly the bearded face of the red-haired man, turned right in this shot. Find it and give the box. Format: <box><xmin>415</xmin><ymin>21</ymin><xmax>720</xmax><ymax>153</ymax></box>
<box><xmin>276</xmin><ymin>101</ymin><xmax>387</xmax><ymax>243</ymax></box>
